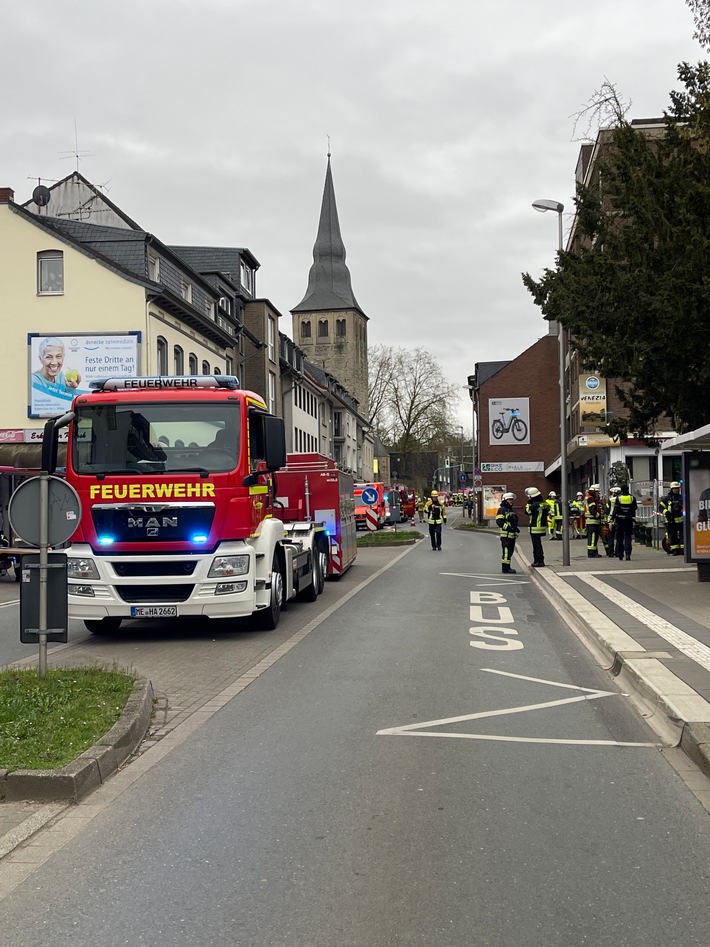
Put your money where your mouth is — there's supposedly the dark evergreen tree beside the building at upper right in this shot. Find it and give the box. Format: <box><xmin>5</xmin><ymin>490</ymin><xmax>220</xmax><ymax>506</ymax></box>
<box><xmin>523</xmin><ymin>62</ymin><xmax>710</xmax><ymax>436</ymax></box>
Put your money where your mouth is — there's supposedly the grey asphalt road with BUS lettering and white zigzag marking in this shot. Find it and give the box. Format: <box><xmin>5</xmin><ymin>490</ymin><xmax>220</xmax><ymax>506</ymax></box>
<box><xmin>0</xmin><ymin>529</ymin><xmax>710</xmax><ymax>947</ymax></box>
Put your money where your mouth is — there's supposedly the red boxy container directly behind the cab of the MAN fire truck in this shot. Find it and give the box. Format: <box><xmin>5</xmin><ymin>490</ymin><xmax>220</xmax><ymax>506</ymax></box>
<box><xmin>274</xmin><ymin>454</ymin><xmax>357</xmax><ymax>577</ymax></box>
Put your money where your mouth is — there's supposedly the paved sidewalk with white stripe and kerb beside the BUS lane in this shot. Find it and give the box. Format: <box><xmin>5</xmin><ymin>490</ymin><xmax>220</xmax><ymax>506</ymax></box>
<box><xmin>516</xmin><ymin>531</ymin><xmax>710</xmax><ymax>776</ymax></box>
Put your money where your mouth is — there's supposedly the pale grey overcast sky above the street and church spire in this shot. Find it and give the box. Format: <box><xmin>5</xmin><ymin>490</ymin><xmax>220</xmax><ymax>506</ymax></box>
<box><xmin>0</xmin><ymin>0</ymin><xmax>703</xmax><ymax>431</ymax></box>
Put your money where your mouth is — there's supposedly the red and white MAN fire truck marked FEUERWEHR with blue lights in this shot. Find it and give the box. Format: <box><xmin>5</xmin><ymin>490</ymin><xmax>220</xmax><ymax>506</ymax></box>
<box><xmin>48</xmin><ymin>375</ymin><xmax>330</xmax><ymax>634</ymax></box>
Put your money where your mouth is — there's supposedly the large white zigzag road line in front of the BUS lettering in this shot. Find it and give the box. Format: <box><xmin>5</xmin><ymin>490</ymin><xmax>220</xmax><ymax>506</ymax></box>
<box><xmin>377</xmin><ymin>668</ymin><xmax>662</xmax><ymax>747</ymax></box>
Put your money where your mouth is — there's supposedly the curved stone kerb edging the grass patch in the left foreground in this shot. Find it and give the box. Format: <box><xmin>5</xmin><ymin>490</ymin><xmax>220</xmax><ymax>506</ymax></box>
<box><xmin>0</xmin><ymin>677</ymin><xmax>153</xmax><ymax>802</ymax></box>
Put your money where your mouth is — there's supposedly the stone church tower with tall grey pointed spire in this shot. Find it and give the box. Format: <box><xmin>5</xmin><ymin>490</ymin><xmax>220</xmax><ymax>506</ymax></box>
<box><xmin>291</xmin><ymin>153</ymin><xmax>369</xmax><ymax>418</ymax></box>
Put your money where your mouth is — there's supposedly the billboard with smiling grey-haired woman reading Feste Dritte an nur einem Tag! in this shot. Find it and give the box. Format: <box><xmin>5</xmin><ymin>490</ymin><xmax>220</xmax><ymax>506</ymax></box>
<box><xmin>27</xmin><ymin>332</ymin><xmax>141</xmax><ymax>418</ymax></box>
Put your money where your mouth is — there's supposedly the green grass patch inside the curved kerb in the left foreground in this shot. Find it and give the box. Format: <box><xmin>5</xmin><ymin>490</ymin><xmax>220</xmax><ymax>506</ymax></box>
<box><xmin>0</xmin><ymin>668</ymin><xmax>136</xmax><ymax>770</ymax></box>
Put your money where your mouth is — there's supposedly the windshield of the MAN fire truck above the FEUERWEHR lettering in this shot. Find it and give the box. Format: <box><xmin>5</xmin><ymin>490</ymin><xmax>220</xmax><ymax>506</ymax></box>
<box><xmin>72</xmin><ymin>401</ymin><xmax>239</xmax><ymax>476</ymax></box>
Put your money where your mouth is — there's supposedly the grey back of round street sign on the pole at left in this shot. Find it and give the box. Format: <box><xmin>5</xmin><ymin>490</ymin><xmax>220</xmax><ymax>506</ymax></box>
<box><xmin>7</xmin><ymin>477</ymin><xmax>81</xmax><ymax>546</ymax></box>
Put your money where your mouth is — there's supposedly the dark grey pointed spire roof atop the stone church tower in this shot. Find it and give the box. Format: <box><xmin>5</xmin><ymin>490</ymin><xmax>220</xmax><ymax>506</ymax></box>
<box><xmin>291</xmin><ymin>156</ymin><xmax>362</xmax><ymax>312</ymax></box>
